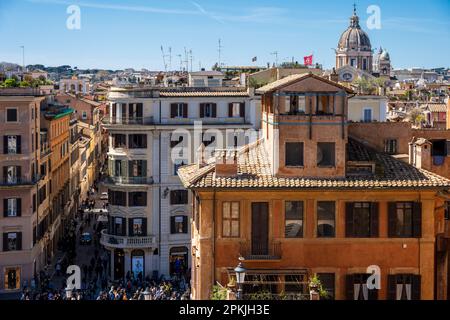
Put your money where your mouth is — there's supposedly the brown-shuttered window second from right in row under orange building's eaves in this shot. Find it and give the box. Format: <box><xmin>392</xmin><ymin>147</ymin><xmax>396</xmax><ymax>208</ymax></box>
<box><xmin>345</xmin><ymin>202</ymin><xmax>378</xmax><ymax>238</ymax></box>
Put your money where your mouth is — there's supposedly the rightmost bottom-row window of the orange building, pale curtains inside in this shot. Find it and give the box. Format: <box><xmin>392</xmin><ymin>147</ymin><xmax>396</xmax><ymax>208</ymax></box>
<box><xmin>388</xmin><ymin>274</ymin><xmax>420</xmax><ymax>300</ymax></box>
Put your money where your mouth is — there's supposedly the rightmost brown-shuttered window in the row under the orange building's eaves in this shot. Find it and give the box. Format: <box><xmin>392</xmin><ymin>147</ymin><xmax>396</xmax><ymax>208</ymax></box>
<box><xmin>388</xmin><ymin>202</ymin><xmax>422</xmax><ymax>238</ymax></box>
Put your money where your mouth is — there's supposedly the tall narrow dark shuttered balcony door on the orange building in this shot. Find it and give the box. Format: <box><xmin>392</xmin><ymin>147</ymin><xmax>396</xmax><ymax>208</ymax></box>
<box><xmin>252</xmin><ymin>202</ymin><xmax>269</xmax><ymax>255</ymax></box>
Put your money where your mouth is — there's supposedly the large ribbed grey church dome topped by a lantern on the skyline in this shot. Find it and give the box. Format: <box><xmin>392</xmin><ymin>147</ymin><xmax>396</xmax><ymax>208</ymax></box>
<box><xmin>338</xmin><ymin>10</ymin><xmax>372</xmax><ymax>51</ymax></box>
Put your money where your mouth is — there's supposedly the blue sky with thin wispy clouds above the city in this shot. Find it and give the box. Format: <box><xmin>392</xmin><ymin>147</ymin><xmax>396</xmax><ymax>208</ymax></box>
<box><xmin>0</xmin><ymin>0</ymin><xmax>450</xmax><ymax>70</ymax></box>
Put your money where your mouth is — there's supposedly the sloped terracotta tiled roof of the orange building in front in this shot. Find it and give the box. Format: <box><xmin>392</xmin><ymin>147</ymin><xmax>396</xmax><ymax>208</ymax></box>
<box><xmin>178</xmin><ymin>138</ymin><xmax>450</xmax><ymax>189</ymax></box>
